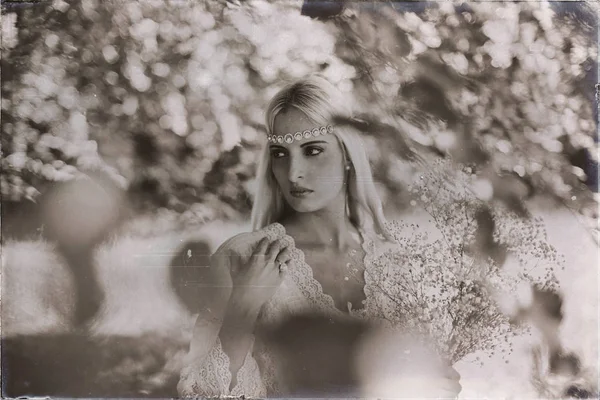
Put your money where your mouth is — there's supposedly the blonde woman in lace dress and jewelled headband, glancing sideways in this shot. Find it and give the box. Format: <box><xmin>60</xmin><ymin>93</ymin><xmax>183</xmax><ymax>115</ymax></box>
<box><xmin>178</xmin><ymin>76</ymin><xmax>457</xmax><ymax>397</ymax></box>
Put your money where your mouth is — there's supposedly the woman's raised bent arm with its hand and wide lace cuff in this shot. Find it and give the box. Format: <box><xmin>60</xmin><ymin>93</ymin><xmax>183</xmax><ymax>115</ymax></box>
<box><xmin>178</xmin><ymin>233</ymin><xmax>289</xmax><ymax>397</ymax></box>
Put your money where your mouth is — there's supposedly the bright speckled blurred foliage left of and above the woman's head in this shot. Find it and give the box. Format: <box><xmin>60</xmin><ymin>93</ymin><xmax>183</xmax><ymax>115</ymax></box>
<box><xmin>3</xmin><ymin>1</ymin><xmax>342</xmax><ymax>216</ymax></box>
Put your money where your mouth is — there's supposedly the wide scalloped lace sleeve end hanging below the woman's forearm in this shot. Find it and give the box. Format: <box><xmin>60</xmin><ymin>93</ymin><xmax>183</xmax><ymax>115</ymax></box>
<box><xmin>177</xmin><ymin>337</ymin><xmax>266</xmax><ymax>398</ymax></box>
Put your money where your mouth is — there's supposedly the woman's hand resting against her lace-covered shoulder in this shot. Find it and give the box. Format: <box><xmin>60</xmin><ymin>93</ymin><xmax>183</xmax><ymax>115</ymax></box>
<box><xmin>230</xmin><ymin>237</ymin><xmax>290</xmax><ymax>312</ymax></box>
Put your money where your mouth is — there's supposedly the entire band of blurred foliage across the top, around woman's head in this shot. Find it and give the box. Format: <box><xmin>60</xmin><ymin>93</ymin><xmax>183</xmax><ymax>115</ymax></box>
<box><xmin>1</xmin><ymin>0</ymin><xmax>597</xmax><ymax>225</ymax></box>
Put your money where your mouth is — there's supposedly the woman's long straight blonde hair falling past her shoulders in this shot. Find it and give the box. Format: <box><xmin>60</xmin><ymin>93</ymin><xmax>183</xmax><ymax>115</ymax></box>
<box><xmin>251</xmin><ymin>75</ymin><xmax>389</xmax><ymax>241</ymax></box>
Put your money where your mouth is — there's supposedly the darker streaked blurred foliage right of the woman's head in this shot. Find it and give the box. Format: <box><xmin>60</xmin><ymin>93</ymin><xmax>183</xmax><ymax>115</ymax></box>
<box><xmin>334</xmin><ymin>2</ymin><xmax>597</xmax><ymax>216</ymax></box>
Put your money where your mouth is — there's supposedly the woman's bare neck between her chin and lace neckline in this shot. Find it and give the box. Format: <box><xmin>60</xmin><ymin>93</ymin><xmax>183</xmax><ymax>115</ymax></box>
<box><xmin>282</xmin><ymin>197</ymin><xmax>356</xmax><ymax>250</ymax></box>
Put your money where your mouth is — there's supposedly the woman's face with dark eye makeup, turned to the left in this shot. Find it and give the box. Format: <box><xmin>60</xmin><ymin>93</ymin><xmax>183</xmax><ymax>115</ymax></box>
<box><xmin>269</xmin><ymin>109</ymin><xmax>346</xmax><ymax>212</ymax></box>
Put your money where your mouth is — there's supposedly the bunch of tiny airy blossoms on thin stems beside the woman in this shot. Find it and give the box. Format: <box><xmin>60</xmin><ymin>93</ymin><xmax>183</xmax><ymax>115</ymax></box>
<box><xmin>372</xmin><ymin>162</ymin><xmax>564</xmax><ymax>362</ymax></box>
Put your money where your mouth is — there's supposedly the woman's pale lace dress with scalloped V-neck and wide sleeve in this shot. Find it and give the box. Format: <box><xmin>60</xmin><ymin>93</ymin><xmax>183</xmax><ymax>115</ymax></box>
<box><xmin>178</xmin><ymin>224</ymin><xmax>394</xmax><ymax>398</ymax></box>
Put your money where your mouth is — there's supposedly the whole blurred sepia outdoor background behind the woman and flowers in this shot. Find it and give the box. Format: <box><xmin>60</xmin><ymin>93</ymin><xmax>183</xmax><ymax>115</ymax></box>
<box><xmin>0</xmin><ymin>0</ymin><xmax>598</xmax><ymax>397</ymax></box>
